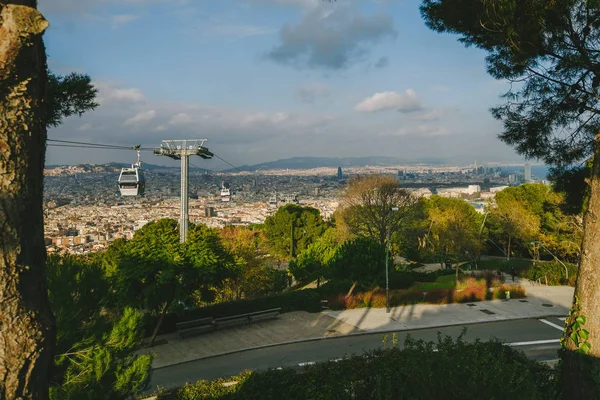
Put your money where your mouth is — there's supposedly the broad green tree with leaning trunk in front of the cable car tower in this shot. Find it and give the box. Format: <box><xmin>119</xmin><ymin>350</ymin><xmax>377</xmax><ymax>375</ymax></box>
<box><xmin>112</xmin><ymin>218</ymin><xmax>235</xmax><ymax>343</ymax></box>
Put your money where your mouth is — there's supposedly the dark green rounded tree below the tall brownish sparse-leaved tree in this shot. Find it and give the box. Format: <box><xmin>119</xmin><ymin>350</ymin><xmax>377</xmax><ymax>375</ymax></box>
<box><xmin>326</xmin><ymin>237</ymin><xmax>386</xmax><ymax>283</ymax></box>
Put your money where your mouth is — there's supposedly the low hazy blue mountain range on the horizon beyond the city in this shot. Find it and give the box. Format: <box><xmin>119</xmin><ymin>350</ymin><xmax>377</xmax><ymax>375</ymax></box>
<box><xmin>224</xmin><ymin>156</ymin><xmax>448</xmax><ymax>172</ymax></box>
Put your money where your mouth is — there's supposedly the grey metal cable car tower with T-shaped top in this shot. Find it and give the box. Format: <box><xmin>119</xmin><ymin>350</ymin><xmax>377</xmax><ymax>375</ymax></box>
<box><xmin>154</xmin><ymin>139</ymin><xmax>214</xmax><ymax>243</ymax></box>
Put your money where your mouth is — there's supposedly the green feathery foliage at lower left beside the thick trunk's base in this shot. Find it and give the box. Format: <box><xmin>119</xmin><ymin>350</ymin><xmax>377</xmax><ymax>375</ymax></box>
<box><xmin>47</xmin><ymin>255</ymin><xmax>151</xmax><ymax>400</ymax></box>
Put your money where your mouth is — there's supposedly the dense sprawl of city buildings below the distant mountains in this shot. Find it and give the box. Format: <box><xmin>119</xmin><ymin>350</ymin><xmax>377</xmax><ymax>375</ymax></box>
<box><xmin>44</xmin><ymin>164</ymin><xmax>548</xmax><ymax>253</ymax></box>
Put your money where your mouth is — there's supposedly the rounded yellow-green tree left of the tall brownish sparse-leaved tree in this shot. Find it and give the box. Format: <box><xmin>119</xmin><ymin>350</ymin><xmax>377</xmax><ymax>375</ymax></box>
<box><xmin>265</xmin><ymin>204</ymin><xmax>326</xmax><ymax>258</ymax></box>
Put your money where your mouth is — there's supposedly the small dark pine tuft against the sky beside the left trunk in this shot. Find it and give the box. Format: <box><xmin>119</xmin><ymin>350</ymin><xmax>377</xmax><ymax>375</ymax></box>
<box><xmin>44</xmin><ymin>72</ymin><xmax>98</xmax><ymax>127</ymax></box>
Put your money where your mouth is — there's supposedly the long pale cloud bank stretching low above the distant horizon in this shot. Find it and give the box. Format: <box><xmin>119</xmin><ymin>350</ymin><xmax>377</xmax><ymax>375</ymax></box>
<box><xmin>47</xmin><ymin>84</ymin><xmax>514</xmax><ymax>169</ymax></box>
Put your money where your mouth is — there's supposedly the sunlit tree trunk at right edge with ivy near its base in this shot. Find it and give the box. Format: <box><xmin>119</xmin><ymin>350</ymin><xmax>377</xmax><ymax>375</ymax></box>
<box><xmin>562</xmin><ymin>134</ymin><xmax>600</xmax><ymax>399</ymax></box>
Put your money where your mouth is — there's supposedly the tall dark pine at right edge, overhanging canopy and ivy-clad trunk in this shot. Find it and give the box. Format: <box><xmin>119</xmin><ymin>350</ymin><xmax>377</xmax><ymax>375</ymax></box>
<box><xmin>421</xmin><ymin>4</ymin><xmax>600</xmax><ymax>384</ymax></box>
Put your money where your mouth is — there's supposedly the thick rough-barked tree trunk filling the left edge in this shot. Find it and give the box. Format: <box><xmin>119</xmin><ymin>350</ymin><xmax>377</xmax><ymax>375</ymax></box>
<box><xmin>0</xmin><ymin>0</ymin><xmax>55</xmax><ymax>399</ymax></box>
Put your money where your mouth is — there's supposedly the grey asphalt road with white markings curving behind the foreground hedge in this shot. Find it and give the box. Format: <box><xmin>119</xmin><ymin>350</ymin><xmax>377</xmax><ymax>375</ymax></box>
<box><xmin>150</xmin><ymin>317</ymin><xmax>564</xmax><ymax>389</ymax></box>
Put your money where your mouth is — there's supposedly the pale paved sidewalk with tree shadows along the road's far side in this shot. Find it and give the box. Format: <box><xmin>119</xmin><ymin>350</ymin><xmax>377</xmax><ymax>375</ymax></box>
<box><xmin>141</xmin><ymin>279</ymin><xmax>573</xmax><ymax>368</ymax></box>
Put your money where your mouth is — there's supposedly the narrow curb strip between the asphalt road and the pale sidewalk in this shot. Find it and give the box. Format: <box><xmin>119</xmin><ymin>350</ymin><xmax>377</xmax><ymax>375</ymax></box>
<box><xmin>152</xmin><ymin>314</ymin><xmax>563</xmax><ymax>371</ymax></box>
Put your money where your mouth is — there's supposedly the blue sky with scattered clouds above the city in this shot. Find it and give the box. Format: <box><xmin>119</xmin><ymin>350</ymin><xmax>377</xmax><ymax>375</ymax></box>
<box><xmin>39</xmin><ymin>0</ymin><xmax>522</xmax><ymax>169</ymax></box>
